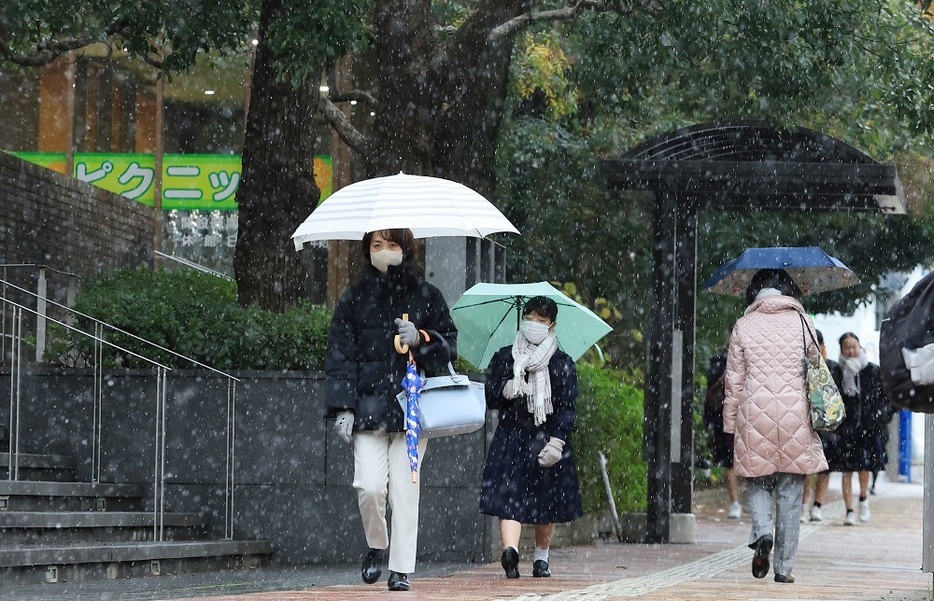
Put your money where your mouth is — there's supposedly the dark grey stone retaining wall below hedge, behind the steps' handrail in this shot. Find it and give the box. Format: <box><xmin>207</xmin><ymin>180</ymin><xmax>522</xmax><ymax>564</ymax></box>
<box><xmin>0</xmin><ymin>368</ymin><xmax>499</xmax><ymax>565</ymax></box>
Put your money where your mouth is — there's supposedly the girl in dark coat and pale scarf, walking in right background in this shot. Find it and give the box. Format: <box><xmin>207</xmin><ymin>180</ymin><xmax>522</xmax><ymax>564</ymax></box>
<box><xmin>830</xmin><ymin>332</ymin><xmax>895</xmax><ymax>526</ymax></box>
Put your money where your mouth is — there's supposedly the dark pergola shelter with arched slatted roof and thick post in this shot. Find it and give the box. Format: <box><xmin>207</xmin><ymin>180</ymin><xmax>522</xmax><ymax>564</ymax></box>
<box><xmin>601</xmin><ymin>121</ymin><xmax>905</xmax><ymax>543</ymax></box>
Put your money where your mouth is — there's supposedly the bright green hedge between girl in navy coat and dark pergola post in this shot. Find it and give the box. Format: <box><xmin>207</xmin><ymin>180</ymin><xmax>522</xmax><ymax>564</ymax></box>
<box><xmin>573</xmin><ymin>363</ymin><xmax>648</xmax><ymax>513</ymax></box>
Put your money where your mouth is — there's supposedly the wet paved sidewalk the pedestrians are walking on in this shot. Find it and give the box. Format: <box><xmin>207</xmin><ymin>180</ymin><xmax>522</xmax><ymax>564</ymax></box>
<box><xmin>0</xmin><ymin>474</ymin><xmax>934</xmax><ymax>601</ymax></box>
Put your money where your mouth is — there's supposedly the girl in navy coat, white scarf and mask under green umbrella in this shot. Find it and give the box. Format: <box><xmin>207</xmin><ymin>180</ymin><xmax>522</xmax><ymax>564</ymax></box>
<box><xmin>480</xmin><ymin>296</ymin><xmax>583</xmax><ymax>578</ymax></box>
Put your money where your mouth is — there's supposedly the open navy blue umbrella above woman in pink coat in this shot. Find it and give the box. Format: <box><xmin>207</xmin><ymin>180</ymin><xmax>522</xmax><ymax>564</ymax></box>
<box><xmin>704</xmin><ymin>246</ymin><xmax>859</xmax><ymax>296</ymax></box>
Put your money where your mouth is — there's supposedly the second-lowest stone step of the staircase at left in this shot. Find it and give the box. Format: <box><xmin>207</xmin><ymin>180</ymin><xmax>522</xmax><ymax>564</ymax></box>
<box><xmin>0</xmin><ymin>511</ymin><xmax>208</xmax><ymax>547</ymax></box>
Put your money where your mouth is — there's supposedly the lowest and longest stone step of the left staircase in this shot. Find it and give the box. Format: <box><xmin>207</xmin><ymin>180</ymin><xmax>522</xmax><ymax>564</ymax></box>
<box><xmin>0</xmin><ymin>540</ymin><xmax>273</xmax><ymax>584</ymax></box>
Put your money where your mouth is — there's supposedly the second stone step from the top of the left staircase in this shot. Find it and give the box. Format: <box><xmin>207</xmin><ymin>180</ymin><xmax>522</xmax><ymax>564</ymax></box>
<box><xmin>0</xmin><ymin>480</ymin><xmax>144</xmax><ymax>511</ymax></box>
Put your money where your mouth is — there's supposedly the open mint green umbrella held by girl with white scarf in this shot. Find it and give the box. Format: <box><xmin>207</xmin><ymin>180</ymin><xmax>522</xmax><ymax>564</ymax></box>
<box><xmin>451</xmin><ymin>282</ymin><xmax>613</xmax><ymax>369</ymax></box>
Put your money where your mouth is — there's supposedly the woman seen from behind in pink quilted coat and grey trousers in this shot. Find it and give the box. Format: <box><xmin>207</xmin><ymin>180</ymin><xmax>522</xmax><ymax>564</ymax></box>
<box><xmin>723</xmin><ymin>269</ymin><xmax>827</xmax><ymax>583</ymax></box>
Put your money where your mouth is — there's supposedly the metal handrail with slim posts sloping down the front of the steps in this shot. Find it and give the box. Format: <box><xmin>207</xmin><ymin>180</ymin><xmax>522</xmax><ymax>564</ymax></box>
<box><xmin>0</xmin><ymin>274</ymin><xmax>240</xmax><ymax>541</ymax></box>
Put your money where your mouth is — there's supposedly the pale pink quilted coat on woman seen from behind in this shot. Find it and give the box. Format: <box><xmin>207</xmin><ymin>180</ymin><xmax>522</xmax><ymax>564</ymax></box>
<box><xmin>723</xmin><ymin>296</ymin><xmax>827</xmax><ymax>478</ymax></box>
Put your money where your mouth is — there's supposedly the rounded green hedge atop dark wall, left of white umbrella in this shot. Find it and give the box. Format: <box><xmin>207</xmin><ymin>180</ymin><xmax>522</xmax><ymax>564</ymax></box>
<box><xmin>45</xmin><ymin>269</ymin><xmax>331</xmax><ymax>370</ymax></box>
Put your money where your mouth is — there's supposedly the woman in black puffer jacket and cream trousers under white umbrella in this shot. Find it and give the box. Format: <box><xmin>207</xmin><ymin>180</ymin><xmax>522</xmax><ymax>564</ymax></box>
<box><xmin>324</xmin><ymin>229</ymin><xmax>457</xmax><ymax>591</ymax></box>
